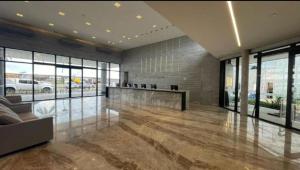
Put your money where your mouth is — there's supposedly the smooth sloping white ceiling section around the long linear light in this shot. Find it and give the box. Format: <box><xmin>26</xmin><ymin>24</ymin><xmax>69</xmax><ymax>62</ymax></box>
<box><xmin>146</xmin><ymin>1</ymin><xmax>300</xmax><ymax>57</ymax></box>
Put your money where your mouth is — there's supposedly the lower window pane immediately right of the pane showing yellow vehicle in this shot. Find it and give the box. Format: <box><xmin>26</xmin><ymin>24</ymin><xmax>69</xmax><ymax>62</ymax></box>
<box><xmin>83</xmin><ymin>69</ymin><xmax>97</xmax><ymax>96</ymax></box>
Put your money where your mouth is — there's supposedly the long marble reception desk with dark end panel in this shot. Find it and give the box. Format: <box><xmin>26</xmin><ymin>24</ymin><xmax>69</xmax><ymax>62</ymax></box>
<box><xmin>106</xmin><ymin>87</ymin><xmax>189</xmax><ymax>111</ymax></box>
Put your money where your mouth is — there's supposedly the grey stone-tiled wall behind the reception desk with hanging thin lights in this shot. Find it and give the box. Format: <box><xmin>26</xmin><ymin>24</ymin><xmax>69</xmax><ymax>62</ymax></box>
<box><xmin>121</xmin><ymin>36</ymin><xmax>220</xmax><ymax>105</ymax></box>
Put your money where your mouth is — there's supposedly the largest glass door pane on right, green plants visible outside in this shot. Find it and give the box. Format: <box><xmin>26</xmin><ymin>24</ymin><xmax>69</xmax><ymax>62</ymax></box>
<box><xmin>259</xmin><ymin>53</ymin><xmax>288</xmax><ymax>125</ymax></box>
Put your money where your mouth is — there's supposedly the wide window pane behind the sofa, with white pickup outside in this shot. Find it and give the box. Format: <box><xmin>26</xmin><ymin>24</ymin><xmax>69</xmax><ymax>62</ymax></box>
<box><xmin>5</xmin><ymin>48</ymin><xmax>33</xmax><ymax>101</ymax></box>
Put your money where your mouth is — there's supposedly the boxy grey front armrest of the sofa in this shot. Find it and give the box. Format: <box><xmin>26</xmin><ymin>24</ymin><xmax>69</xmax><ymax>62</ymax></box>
<box><xmin>0</xmin><ymin>117</ymin><xmax>53</xmax><ymax>156</ymax></box>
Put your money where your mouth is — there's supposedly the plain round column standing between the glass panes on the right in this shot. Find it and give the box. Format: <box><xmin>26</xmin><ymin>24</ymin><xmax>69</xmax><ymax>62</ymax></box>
<box><xmin>240</xmin><ymin>50</ymin><xmax>249</xmax><ymax>116</ymax></box>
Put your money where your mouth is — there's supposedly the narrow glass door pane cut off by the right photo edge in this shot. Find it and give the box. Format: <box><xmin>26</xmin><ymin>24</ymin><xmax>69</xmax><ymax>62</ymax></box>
<box><xmin>291</xmin><ymin>54</ymin><xmax>300</xmax><ymax>129</ymax></box>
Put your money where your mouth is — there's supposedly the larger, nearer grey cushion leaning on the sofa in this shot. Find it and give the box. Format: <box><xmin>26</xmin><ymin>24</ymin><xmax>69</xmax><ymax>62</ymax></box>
<box><xmin>0</xmin><ymin>103</ymin><xmax>22</xmax><ymax>125</ymax></box>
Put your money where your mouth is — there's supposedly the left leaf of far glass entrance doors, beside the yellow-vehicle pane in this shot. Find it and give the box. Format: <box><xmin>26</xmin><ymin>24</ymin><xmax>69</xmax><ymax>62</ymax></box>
<box><xmin>56</xmin><ymin>67</ymin><xmax>70</xmax><ymax>98</ymax></box>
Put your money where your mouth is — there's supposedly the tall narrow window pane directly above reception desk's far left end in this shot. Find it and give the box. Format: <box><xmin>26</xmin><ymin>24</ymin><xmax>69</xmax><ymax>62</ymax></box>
<box><xmin>98</xmin><ymin>62</ymin><xmax>109</xmax><ymax>95</ymax></box>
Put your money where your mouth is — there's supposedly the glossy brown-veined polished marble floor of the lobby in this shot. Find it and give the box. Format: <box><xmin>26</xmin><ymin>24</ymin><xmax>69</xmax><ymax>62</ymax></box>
<box><xmin>0</xmin><ymin>97</ymin><xmax>300</xmax><ymax>170</ymax></box>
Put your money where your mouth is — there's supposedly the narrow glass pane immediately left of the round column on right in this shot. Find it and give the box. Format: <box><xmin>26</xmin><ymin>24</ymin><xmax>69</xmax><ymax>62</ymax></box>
<box><xmin>224</xmin><ymin>58</ymin><xmax>236</xmax><ymax>110</ymax></box>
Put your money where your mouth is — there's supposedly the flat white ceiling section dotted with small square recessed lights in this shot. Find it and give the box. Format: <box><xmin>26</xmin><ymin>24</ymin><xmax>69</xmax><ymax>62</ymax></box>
<box><xmin>0</xmin><ymin>1</ymin><xmax>184</xmax><ymax>49</ymax></box>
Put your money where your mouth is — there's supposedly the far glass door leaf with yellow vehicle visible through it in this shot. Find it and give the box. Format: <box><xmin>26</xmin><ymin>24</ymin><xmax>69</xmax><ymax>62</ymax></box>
<box><xmin>71</xmin><ymin>68</ymin><xmax>82</xmax><ymax>97</ymax></box>
